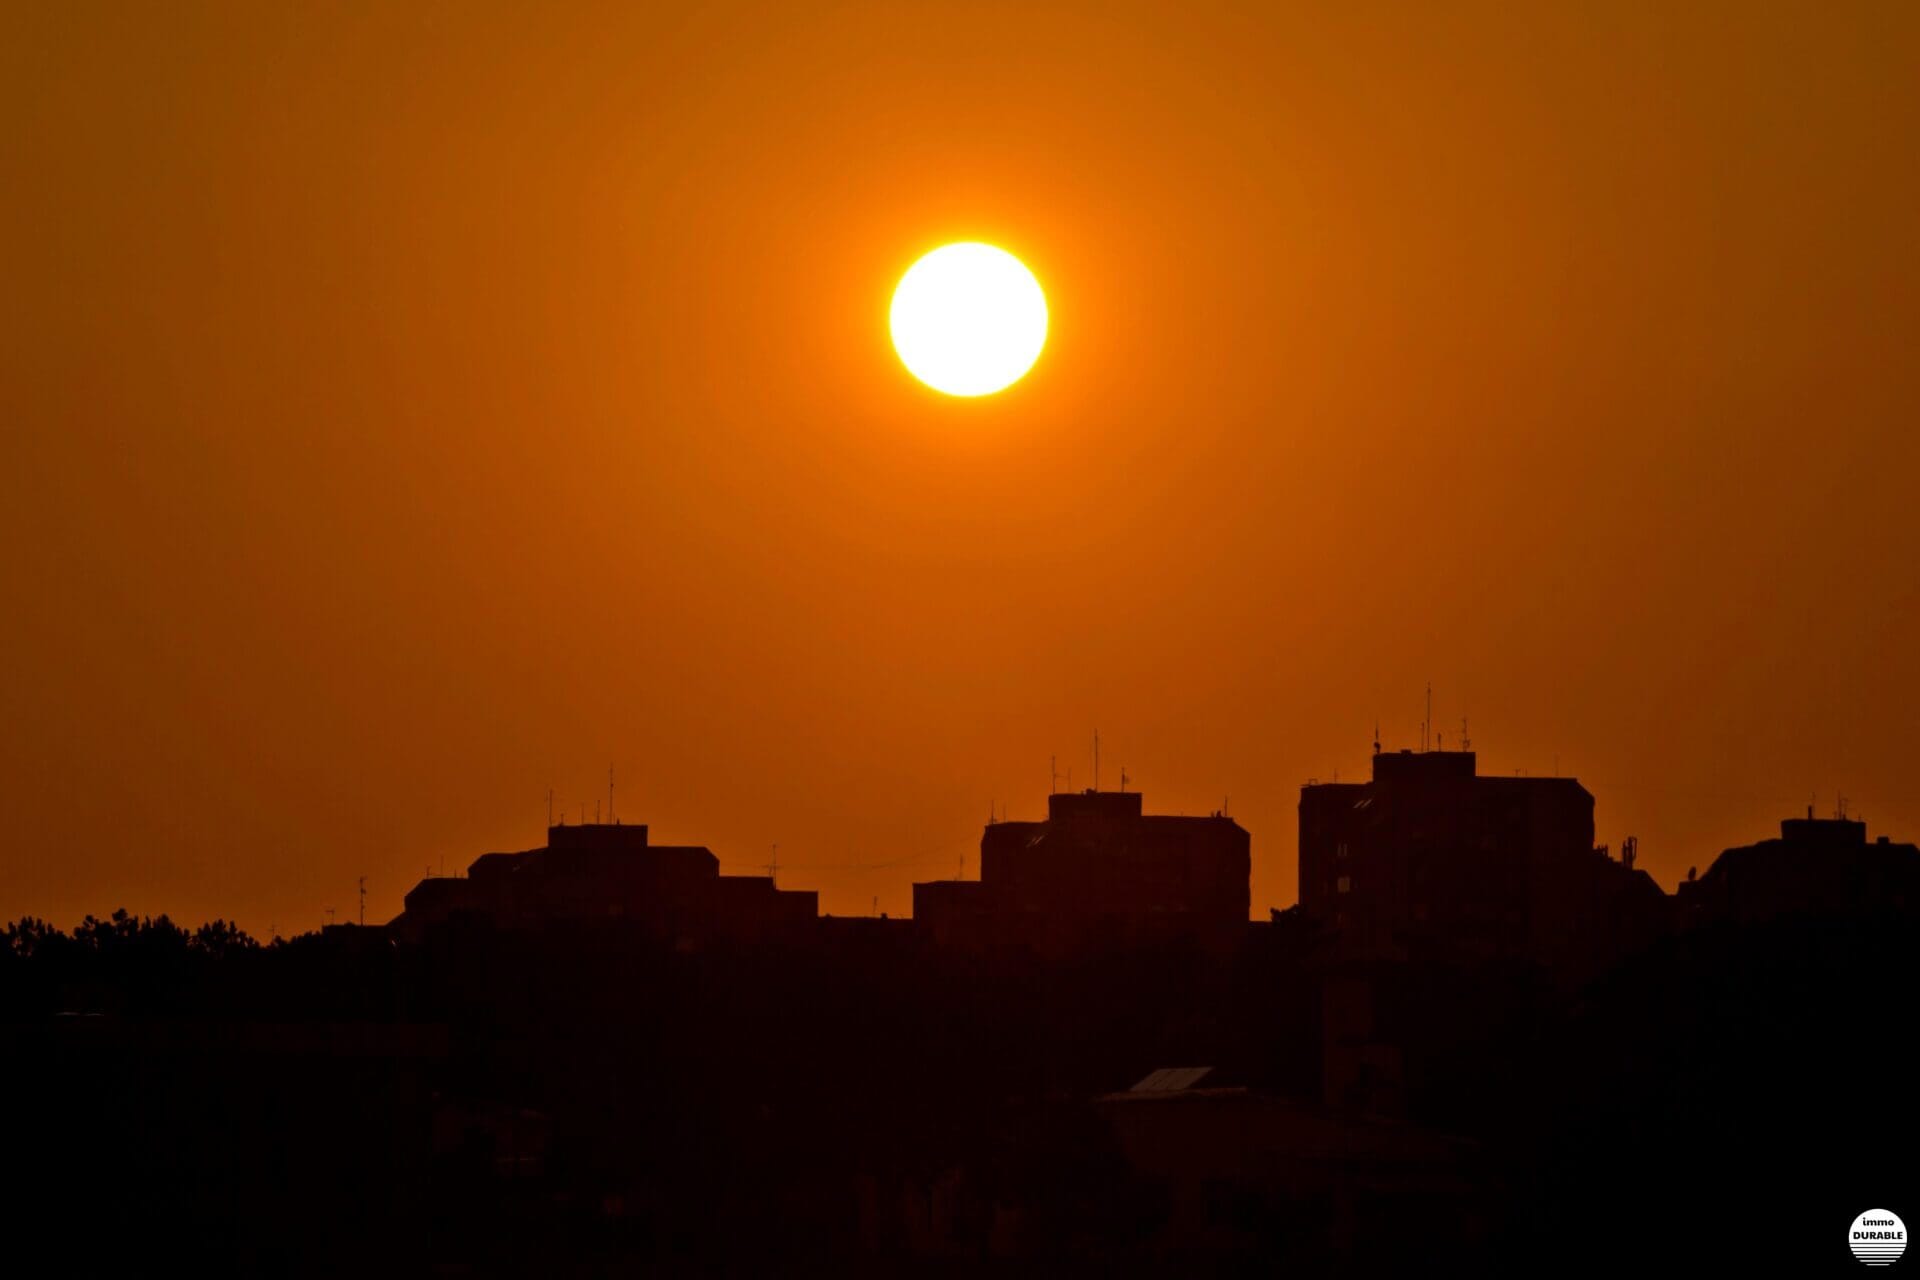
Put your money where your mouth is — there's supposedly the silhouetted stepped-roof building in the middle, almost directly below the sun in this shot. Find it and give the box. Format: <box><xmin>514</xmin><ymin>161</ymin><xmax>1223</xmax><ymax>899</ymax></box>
<box><xmin>914</xmin><ymin>791</ymin><xmax>1252</xmax><ymax>942</ymax></box>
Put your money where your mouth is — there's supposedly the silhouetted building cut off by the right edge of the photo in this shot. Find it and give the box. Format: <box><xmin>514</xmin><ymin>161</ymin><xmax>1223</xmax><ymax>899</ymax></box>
<box><xmin>1680</xmin><ymin>808</ymin><xmax>1920</xmax><ymax>923</ymax></box>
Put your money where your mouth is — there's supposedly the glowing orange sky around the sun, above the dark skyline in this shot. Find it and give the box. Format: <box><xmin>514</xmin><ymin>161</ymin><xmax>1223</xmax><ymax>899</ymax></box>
<box><xmin>0</xmin><ymin>0</ymin><xmax>1920</xmax><ymax>933</ymax></box>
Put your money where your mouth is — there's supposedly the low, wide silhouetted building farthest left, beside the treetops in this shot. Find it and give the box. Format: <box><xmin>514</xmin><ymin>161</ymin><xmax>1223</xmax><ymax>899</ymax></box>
<box><xmin>390</xmin><ymin>823</ymin><xmax>820</xmax><ymax>940</ymax></box>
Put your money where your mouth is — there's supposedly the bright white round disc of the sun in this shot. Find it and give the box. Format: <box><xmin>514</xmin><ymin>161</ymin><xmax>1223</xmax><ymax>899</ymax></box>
<box><xmin>889</xmin><ymin>242</ymin><xmax>1046</xmax><ymax>395</ymax></box>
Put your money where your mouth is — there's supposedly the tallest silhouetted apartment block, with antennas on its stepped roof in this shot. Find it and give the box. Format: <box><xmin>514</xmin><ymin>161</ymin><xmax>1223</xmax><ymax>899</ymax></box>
<box><xmin>1300</xmin><ymin>750</ymin><xmax>1667</xmax><ymax>969</ymax></box>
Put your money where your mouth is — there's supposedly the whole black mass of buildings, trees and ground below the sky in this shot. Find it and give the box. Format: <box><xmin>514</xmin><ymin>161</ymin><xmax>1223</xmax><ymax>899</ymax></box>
<box><xmin>0</xmin><ymin>752</ymin><xmax>1920</xmax><ymax>1274</ymax></box>
